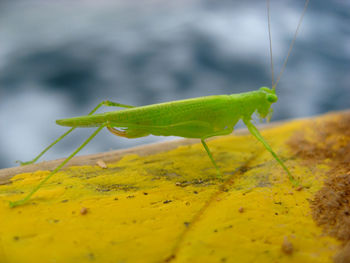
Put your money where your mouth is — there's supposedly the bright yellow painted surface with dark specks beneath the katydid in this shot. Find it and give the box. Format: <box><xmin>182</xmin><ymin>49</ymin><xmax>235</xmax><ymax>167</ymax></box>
<box><xmin>0</xmin><ymin>117</ymin><xmax>339</xmax><ymax>263</ymax></box>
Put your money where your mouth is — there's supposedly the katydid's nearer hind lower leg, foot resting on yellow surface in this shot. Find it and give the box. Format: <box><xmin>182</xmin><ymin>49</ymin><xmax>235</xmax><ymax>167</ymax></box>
<box><xmin>10</xmin><ymin>123</ymin><xmax>106</xmax><ymax>207</ymax></box>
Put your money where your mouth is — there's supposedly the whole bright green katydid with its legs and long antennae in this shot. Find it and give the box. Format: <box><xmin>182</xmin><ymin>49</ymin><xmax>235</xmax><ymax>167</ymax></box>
<box><xmin>10</xmin><ymin>0</ymin><xmax>309</xmax><ymax>207</ymax></box>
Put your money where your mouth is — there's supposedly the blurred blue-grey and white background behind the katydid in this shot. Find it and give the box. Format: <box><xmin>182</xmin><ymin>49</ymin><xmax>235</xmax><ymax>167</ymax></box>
<box><xmin>0</xmin><ymin>0</ymin><xmax>350</xmax><ymax>168</ymax></box>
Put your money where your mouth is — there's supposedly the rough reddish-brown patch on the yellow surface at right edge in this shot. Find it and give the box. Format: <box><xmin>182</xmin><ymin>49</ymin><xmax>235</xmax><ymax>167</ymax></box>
<box><xmin>288</xmin><ymin>112</ymin><xmax>350</xmax><ymax>262</ymax></box>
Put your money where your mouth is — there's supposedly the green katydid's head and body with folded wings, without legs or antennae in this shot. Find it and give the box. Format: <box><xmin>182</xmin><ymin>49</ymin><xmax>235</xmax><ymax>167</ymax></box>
<box><xmin>56</xmin><ymin>87</ymin><xmax>277</xmax><ymax>139</ymax></box>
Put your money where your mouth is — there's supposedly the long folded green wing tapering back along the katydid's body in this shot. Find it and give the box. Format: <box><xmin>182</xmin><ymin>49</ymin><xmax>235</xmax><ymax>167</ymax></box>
<box><xmin>56</xmin><ymin>95</ymin><xmax>230</xmax><ymax>127</ymax></box>
